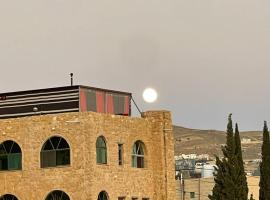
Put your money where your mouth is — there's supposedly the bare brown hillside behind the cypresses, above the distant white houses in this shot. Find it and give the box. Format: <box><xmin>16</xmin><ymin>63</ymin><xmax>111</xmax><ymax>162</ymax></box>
<box><xmin>173</xmin><ymin>126</ymin><xmax>262</xmax><ymax>159</ymax></box>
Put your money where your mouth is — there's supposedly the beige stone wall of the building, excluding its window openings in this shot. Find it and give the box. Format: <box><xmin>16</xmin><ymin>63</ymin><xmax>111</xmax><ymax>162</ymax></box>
<box><xmin>0</xmin><ymin>111</ymin><xmax>175</xmax><ymax>200</ymax></box>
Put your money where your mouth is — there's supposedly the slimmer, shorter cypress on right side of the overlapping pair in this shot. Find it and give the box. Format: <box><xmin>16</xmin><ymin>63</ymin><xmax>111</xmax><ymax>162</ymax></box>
<box><xmin>234</xmin><ymin>123</ymin><xmax>248</xmax><ymax>200</ymax></box>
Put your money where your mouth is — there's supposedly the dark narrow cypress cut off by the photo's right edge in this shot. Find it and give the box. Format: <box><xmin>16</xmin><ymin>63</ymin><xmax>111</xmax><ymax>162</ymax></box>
<box><xmin>259</xmin><ymin>121</ymin><xmax>270</xmax><ymax>200</ymax></box>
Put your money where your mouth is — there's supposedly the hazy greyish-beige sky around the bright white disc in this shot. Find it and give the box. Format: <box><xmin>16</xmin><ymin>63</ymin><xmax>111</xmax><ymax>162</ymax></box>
<box><xmin>0</xmin><ymin>0</ymin><xmax>270</xmax><ymax>130</ymax></box>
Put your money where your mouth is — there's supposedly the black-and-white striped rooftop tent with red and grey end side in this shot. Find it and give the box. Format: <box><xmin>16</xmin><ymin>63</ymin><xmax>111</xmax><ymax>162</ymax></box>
<box><xmin>0</xmin><ymin>85</ymin><xmax>131</xmax><ymax>119</ymax></box>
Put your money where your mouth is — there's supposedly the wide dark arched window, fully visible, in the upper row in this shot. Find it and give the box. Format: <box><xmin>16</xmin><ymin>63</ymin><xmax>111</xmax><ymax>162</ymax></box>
<box><xmin>40</xmin><ymin>136</ymin><xmax>70</xmax><ymax>168</ymax></box>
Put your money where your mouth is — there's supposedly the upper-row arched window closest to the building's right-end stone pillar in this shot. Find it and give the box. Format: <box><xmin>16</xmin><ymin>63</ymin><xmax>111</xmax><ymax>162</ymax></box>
<box><xmin>132</xmin><ymin>141</ymin><xmax>144</xmax><ymax>168</ymax></box>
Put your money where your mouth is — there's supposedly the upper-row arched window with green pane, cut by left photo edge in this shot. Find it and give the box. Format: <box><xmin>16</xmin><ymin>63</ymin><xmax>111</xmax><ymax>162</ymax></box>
<box><xmin>0</xmin><ymin>140</ymin><xmax>22</xmax><ymax>171</ymax></box>
